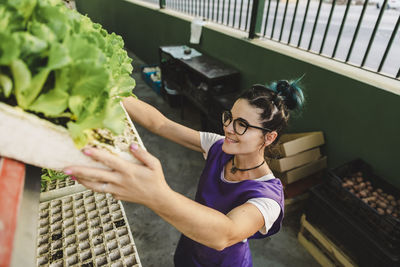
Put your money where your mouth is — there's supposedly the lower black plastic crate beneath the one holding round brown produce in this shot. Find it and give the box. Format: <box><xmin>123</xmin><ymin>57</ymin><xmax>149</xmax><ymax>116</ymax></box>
<box><xmin>305</xmin><ymin>184</ymin><xmax>400</xmax><ymax>267</ymax></box>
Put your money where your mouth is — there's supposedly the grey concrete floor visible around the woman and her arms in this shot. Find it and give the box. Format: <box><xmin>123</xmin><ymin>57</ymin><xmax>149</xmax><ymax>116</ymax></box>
<box><xmin>124</xmin><ymin>53</ymin><xmax>319</xmax><ymax>267</ymax></box>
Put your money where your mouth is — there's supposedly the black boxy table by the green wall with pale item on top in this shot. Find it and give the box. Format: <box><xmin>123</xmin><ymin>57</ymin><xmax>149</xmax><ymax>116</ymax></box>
<box><xmin>159</xmin><ymin>46</ymin><xmax>240</xmax><ymax>117</ymax></box>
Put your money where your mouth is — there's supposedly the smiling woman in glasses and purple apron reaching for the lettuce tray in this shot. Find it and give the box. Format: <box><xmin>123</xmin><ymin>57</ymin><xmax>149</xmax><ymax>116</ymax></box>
<box><xmin>64</xmin><ymin>78</ymin><xmax>304</xmax><ymax>267</ymax></box>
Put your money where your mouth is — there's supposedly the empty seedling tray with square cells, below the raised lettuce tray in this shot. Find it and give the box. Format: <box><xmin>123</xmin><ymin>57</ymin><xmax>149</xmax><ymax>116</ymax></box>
<box><xmin>36</xmin><ymin>190</ymin><xmax>141</xmax><ymax>267</ymax></box>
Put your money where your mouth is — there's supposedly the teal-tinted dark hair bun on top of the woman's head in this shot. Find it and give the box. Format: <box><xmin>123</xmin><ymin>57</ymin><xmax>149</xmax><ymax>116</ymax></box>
<box><xmin>271</xmin><ymin>79</ymin><xmax>304</xmax><ymax>110</ymax></box>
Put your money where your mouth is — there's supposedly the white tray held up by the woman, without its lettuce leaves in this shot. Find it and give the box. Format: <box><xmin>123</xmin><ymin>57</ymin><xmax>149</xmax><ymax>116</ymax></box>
<box><xmin>0</xmin><ymin>102</ymin><xmax>143</xmax><ymax>173</ymax></box>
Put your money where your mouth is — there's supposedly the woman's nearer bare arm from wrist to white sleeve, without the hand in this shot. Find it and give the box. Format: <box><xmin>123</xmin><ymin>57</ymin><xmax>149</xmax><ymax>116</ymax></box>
<box><xmin>150</xmin><ymin>191</ymin><xmax>264</xmax><ymax>250</ymax></box>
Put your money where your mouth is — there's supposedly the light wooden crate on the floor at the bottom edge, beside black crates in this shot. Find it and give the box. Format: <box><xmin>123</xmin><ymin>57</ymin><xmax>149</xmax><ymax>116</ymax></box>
<box><xmin>297</xmin><ymin>214</ymin><xmax>357</xmax><ymax>267</ymax></box>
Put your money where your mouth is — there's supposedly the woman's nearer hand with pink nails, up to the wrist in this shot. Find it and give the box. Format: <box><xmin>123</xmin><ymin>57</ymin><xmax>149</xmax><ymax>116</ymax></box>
<box><xmin>64</xmin><ymin>144</ymin><xmax>170</xmax><ymax>206</ymax></box>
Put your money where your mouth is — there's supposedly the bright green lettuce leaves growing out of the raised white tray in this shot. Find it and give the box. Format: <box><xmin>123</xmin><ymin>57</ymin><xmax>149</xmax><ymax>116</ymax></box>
<box><xmin>0</xmin><ymin>0</ymin><xmax>135</xmax><ymax>148</ymax></box>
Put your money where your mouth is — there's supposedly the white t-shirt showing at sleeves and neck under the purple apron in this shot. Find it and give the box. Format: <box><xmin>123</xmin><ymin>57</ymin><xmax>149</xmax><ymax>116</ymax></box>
<box><xmin>200</xmin><ymin>132</ymin><xmax>281</xmax><ymax>234</ymax></box>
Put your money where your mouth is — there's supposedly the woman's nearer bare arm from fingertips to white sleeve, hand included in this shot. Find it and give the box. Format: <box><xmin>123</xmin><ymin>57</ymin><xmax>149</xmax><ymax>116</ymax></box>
<box><xmin>64</xmin><ymin>145</ymin><xmax>264</xmax><ymax>250</ymax></box>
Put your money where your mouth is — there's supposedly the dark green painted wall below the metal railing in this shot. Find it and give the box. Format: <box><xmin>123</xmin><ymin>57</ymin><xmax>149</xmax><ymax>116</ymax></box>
<box><xmin>77</xmin><ymin>0</ymin><xmax>400</xmax><ymax>188</ymax></box>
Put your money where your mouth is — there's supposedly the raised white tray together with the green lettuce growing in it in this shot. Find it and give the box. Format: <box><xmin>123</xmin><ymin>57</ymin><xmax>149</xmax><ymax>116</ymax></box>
<box><xmin>0</xmin><ymin>0</ymin><xmax>139</xmax><ymax>170</ymax></box>
